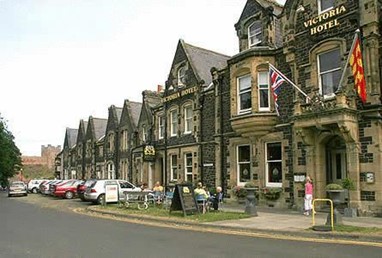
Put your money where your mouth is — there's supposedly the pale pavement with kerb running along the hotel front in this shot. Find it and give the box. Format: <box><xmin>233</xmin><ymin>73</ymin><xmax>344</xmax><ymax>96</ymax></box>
<box><xmin>84</xmin><ymin>202</ymin><xmax>382</xmax><ymax>247</ymax></box>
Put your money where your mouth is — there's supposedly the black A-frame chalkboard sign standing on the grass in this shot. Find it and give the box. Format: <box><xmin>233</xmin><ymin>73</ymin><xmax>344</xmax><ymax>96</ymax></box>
<box><xmin>170</xmin><ymin>184</ymin><xmax>199</xmax><ymax>216</ymax></box>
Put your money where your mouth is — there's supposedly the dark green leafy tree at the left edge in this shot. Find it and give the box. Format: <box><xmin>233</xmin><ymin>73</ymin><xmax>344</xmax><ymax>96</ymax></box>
<box><xmin>0</xmin><ymin>116</ymin><xmax>22</xmax><ymax>187</ymax></box>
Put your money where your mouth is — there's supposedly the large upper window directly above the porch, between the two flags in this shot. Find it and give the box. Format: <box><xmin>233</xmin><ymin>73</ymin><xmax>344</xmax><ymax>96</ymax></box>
<box><xmin>317</xmin><ymin>48</ymin><xmax>342</xmax><ymax>97</ymax></box>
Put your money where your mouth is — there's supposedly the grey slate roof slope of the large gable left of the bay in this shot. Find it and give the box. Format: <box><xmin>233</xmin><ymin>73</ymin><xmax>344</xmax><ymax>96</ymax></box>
<box><xmin>180</xmin><ymin>39</ymin><xmax>230</xmax><ymax>85</ymax></box>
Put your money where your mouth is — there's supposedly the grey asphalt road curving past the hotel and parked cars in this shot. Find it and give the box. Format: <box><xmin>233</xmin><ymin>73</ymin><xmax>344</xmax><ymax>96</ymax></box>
<box><xmin>0</xmin><ymin>193</ymin><xmax>382</xmax><ymax>258</ymax></box>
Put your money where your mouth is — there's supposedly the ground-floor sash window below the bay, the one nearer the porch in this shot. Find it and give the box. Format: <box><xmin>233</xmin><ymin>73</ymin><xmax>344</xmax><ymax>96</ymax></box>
<box><xmin>265</xmin><ymin>142</ymin><xmax>282</xmax><ymax>187</ymax></box>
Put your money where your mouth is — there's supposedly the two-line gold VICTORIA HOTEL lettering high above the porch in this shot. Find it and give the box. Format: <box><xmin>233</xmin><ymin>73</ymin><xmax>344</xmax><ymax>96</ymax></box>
<box><xmin>304</xmin><ymin>5</ymin><xmax>346</xmax><ymax>35</ymax></box>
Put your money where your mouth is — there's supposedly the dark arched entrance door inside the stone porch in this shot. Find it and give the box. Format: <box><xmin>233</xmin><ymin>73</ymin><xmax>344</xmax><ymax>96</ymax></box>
<box><xmin>326</xmin><ymin>137</ymin><xmax>347</xmax><ymax>183</ymax></box>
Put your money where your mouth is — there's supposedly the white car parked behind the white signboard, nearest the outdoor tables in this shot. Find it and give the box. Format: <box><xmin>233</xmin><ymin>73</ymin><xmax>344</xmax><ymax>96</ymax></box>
<box><xmin>84</xmin><ymin>179</ymin><xmax>142</xmax><ymax>204</ymax></box>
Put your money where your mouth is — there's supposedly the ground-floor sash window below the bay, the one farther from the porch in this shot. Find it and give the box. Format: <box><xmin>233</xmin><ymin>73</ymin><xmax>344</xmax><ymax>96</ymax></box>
<box><xmin>237</xmin><ymin>145</ymin><xmax>251</xmax><ymax>183</ymax></box>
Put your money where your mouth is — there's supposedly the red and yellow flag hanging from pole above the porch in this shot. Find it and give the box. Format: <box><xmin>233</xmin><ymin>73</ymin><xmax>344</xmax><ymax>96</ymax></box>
<box><xmin>349</xmin><ymin>36</ymin><xmax>366</xmax><ymax>103</ymax></box>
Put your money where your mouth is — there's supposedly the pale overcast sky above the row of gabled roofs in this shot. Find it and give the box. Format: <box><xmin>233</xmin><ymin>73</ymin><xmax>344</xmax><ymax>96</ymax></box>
<box><xmin>0</xmin><ymin>0</ymin><xmax>284</xmax><ymax>156</ymax></box>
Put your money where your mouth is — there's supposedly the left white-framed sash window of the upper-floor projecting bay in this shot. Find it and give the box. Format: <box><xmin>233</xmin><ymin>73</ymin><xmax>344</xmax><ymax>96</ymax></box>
<box><xmin>237</xmin><ymin>75</ymin><xmax>252</xmax><ymax>113</ymax></box>
